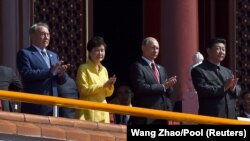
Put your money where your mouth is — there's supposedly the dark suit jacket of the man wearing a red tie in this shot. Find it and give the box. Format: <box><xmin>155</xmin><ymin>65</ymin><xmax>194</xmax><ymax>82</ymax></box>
<box><xmin>129</xmin><ymin>58</ymin><xmax>173</xmax><ymax>124</ymax></box>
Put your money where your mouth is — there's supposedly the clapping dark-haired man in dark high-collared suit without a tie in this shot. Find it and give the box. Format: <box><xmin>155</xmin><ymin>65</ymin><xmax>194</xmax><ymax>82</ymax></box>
<box><xmin>191</xmin><ymin>38</ymin><xmax>241</xmax><ymax>119</ymax></box>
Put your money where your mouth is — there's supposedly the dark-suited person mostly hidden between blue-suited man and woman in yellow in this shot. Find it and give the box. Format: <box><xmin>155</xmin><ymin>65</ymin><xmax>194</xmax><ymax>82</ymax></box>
<box><xmin>58</xmin><ymin>77</ymin><xmax>79</xmax><ymax>118</ymax></box>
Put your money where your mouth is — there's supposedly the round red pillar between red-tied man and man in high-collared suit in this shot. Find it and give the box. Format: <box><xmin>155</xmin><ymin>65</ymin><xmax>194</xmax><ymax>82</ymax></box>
<box><xmin>160</xmin><ymin>0</ymin><xmax>199</xmax><ymax>117</ymax></box>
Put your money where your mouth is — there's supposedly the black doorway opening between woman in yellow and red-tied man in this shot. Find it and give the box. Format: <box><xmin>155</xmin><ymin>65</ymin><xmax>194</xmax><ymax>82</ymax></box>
<box><xmin>93</xmin><ymin>0</ymin><xmax>143</xmax><ymax>99</ymax></box>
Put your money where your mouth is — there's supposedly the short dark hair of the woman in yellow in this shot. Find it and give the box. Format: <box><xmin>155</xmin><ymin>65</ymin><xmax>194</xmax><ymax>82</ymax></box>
<box><xmin>87</xmin><ymin>36</ymin><xmax>107</xmax><ymax>51</ymax></box>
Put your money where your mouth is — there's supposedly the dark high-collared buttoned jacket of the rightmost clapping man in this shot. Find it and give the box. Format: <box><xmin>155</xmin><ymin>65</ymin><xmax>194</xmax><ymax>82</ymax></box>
<box><xmin>191</xmin><ymin>60</ymin><xmax>241</xmax><ymax>118</ymax></box>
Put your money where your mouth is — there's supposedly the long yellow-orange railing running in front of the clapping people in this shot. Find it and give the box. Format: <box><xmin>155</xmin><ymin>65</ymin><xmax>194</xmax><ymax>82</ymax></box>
<box><xmin>0</xmin><ymin>90</ymin><xmax>250</xmax><ymax>125</ymax></box>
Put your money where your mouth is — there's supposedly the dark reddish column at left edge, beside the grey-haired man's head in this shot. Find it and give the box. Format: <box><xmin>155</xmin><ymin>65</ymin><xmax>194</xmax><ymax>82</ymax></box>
<box><xmin>0</xmin><ymin>0</ymin><xmax>30</xmax><ymax>68</ymax></box>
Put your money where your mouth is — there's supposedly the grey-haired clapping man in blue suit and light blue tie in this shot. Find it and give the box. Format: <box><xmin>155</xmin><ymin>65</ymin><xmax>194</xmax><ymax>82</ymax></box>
<box><xmin>16</xmin><ymin>23</ymin><xmax>68</xmax><ymax>116</ymax></box>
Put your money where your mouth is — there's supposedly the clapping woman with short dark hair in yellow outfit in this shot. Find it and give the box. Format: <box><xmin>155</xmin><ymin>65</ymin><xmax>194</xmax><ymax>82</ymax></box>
<box><xmin>76</xmin><ymin>36</ymin><xmax>116</xmax><ymax>123</ymax></box>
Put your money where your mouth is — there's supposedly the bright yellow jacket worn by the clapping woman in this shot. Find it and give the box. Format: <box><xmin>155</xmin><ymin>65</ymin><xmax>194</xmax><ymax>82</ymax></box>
<box><xmin>76</xmin><ymin>60</ymin><xmax>114</xmax><ymax>123</ymax></box>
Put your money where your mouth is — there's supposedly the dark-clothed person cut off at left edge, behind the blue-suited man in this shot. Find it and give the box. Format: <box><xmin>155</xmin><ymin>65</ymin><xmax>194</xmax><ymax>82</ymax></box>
<box><xmin>0</xmin><ymin>66</ymin><xmax>22</xmax><ymax>112</ymax></box>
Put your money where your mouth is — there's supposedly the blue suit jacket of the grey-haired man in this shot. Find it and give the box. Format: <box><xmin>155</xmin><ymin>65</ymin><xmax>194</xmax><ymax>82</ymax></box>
<box><xmin>16</xmin><ymin>46</ymin><xmax>67</xmax><ymax>115</ymax></box>
